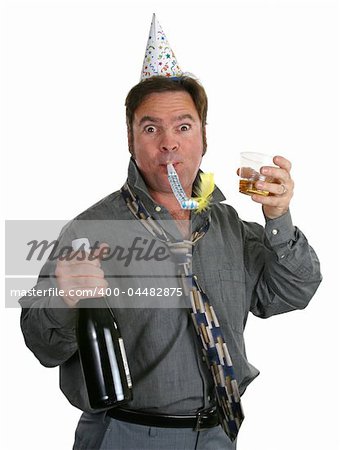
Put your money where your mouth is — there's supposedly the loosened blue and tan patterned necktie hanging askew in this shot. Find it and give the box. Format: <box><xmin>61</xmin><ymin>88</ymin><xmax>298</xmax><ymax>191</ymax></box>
<box><xmin>121</xmin><ymin>183</ymin><xmax>244</xmax><ymax>441</ymax></box>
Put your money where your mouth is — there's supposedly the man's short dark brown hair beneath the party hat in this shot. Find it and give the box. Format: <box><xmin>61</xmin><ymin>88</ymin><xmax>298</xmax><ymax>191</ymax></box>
<box><xmin>125</xmin><ymin>75</ymin><xmax>208</xmax><ymax>155</ymax></box>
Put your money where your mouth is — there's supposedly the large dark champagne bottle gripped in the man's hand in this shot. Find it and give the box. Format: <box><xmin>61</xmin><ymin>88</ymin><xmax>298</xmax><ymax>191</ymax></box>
<box><xmin>72</xmin><ymin>238</ymin><xmax>132</xmax><ymax>409</ymax></box>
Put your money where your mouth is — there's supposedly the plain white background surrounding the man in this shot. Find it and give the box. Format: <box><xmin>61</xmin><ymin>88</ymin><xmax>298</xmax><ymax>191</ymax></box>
<box><xmin>1</xmin><ymin>0</ymin><xmax>339</xmax><ymax>450</ymax></box>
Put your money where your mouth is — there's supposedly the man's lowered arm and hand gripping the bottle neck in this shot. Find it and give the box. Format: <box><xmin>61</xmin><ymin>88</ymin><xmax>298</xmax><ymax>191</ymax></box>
<box><xmin>19</xmin><ymin>230</ymin><xmax>107</xmax><ymax>367</ymax></box>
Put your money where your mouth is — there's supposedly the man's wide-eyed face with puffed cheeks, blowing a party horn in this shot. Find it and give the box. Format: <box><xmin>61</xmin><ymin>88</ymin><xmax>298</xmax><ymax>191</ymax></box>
<box><xmin>129</xmin><ymin>91</ymin><xmax>203</xmax><ymax>195</ymax></box>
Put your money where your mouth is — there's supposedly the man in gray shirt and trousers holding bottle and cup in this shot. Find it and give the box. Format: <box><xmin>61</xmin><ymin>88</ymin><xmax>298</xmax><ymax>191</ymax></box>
<box><xmin>21</xmin><ymin>14</ymin><xmax>321</xmax><ymax>450</ymax></box>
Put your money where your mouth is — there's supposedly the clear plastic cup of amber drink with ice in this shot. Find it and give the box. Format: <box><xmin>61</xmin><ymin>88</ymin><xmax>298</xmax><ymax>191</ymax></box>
<box><xmin>239</xmin><ymin>152</ymin><xmax>276</xmax><ymax>196</ymax></box>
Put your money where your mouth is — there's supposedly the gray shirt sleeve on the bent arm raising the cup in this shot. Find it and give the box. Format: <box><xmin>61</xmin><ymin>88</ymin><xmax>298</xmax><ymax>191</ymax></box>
<box><xmin>245</xmin><ymin>211</ymin><xmax>322</xmax><ymax>318</ymax></box>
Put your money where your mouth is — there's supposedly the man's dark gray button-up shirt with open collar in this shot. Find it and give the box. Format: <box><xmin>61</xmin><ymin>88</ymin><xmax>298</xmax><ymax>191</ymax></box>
<box><xmin>20</xmin><ymin>160</ymin><xmax>321</xmax><ymax>414</ymax></box>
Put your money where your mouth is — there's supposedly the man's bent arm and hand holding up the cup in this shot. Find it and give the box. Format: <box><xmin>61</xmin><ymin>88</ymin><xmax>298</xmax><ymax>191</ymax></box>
<box><xmin>238</xmin><ymin>156</ymin><xmax>321</xmax><ymax>317</ymax></box>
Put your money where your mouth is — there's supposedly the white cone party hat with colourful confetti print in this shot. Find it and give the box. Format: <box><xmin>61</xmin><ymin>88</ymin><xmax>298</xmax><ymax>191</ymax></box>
<box><xmin>140</xmin><ymin>14</ymin><xmax>183</xmax><ymax>81</ymax></box>
